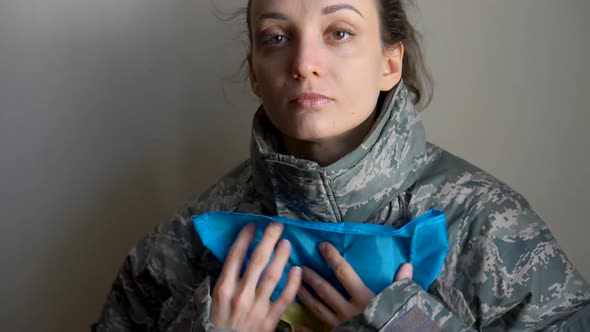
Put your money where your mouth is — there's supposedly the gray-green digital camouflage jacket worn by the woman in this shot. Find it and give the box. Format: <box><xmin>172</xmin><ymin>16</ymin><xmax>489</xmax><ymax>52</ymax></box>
<box><xmin>93</xmin><ymin>83</ymin><xmax>590</xmax><ymax>331</ymax></box>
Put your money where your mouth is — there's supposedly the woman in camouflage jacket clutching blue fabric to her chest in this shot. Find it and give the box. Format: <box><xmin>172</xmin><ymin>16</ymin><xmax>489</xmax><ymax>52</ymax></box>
<box><xmin>94</xmin><ymin>0</ymin><xmax>590</xmax><ymax>331</ymax></box>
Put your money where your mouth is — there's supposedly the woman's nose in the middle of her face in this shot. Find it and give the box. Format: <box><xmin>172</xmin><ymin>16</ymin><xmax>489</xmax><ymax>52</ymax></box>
<box><xmin>291</xmin><ymin>34</ymin><xmax>323</xmax><ymax>80</ymax></box>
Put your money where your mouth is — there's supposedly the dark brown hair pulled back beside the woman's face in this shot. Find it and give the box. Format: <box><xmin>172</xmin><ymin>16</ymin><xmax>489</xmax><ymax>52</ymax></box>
<box><xmin>245</xmin><ymin>0</ymin><xmax>434</xmax><ymax>109</ymax></box>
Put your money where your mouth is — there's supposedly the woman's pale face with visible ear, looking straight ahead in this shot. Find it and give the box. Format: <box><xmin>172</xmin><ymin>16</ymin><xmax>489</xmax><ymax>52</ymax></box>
<box><xmin>248</xmin><ymin>0</ymin><xmax>403</xmax><ymax>142</ymax></box>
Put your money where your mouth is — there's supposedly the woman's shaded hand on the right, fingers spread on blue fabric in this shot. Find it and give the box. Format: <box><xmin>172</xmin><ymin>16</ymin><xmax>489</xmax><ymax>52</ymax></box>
<box><xmin>297</xmin><ymin>242</ymin><xmax>413</xmax><ymax>331</ymax></box>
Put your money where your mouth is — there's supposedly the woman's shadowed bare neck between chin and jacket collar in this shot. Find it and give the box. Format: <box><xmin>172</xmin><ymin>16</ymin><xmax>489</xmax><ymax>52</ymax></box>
<box><xmin>283</xmin><ymin>111</ymin><xmax>378</xmax><ymax>166</ymax></box>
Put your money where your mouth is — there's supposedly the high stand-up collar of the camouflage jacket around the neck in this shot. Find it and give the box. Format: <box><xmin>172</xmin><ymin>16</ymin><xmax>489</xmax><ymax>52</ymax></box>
<box><xmin>251</xmin><ymin>82</ymin><xmax>426</xmax><ymax>222</ymax></box>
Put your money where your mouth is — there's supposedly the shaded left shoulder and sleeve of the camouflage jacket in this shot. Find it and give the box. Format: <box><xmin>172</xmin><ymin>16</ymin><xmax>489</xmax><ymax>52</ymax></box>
<box><xmin>94</xmin><ymin>161</ymin><xmax>252</xmax><ymax>330</ymax></box>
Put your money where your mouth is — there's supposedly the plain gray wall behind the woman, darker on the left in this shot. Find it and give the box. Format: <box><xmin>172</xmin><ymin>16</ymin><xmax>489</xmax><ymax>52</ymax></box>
<box><xmin>0</xmin><ymin>0</ymin><xmax>590</xmax><ymax>331</ymax></box>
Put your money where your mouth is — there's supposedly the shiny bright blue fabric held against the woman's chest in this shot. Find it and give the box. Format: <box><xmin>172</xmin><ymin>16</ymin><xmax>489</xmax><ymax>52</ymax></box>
<box><xmin>192</xmin><ymin>210</ymin><xmax>449</xmax><ymax>300</ymax></box>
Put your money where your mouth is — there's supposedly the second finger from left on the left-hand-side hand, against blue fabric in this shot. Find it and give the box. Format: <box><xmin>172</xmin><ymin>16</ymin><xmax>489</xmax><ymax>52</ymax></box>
<box><xmin>243</xmin><ymin>222</ymin><xmax>284</xmax><ymax>289</ymax></box>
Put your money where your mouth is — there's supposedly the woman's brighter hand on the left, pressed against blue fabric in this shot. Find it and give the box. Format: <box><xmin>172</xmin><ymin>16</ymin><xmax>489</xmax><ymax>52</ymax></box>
<box><xmin>209</xmin><ymin>223</ymin><xmax>301</xmax><ymax>331</ymax></box>
